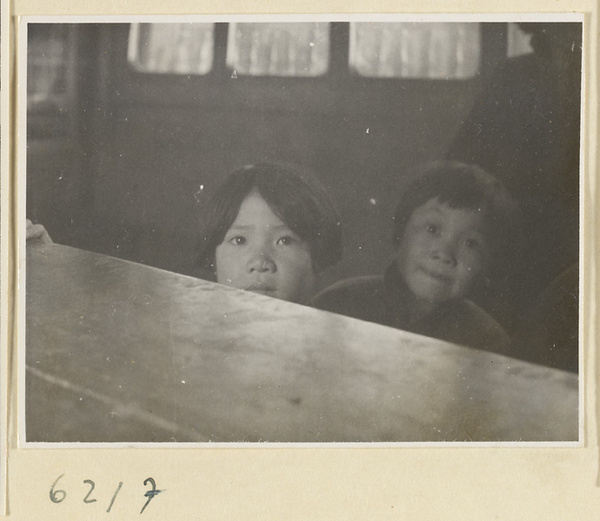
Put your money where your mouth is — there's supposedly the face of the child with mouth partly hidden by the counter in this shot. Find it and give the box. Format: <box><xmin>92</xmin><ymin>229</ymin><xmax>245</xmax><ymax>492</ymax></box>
<box><xmin>215</xmin><ymin>191</ymin><xmax>316</xmax><ymax>303</ymax></box>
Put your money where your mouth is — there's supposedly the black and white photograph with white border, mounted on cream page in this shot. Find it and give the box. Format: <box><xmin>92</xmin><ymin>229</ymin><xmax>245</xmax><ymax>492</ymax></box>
<box><xmin>22</xmin><ymin>18</ymin><xmax>585</xmax><ymax>447</ymax></box>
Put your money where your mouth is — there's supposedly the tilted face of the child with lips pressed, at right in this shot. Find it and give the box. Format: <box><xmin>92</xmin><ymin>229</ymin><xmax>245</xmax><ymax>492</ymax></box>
<box><xmin>396</xmin><ymin>198</ymin><xmax>488</xmax><ymax>306</ymax></box>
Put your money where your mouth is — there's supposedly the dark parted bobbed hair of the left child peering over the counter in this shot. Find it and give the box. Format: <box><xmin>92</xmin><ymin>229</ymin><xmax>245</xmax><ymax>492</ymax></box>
<box><xmin>199</xmin><ymin>162</ymin><xmax>342</xmax><ymax>278</ymax></box>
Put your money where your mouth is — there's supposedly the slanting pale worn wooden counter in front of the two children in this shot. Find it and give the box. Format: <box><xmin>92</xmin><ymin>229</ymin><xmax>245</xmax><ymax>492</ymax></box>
<box><xmin>25</xmin><ymin>243</ymin><xmax>578</xmax><ymax>442</ymax></box>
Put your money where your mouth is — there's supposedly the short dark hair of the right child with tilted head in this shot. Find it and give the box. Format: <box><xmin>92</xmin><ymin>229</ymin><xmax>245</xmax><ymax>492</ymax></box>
<box><xmin>393</xmin><ymin>161</ymin><xmax>521</xmax><ymax>278</ymax></box>
